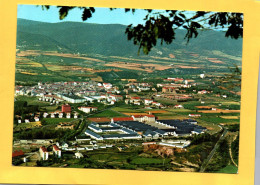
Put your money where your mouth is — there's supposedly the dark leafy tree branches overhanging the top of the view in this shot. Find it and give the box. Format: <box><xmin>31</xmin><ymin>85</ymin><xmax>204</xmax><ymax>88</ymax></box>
<box><xmin>42</xmin><ymin>5</ymin><xmax>243</xmax><ymax>54</ymax></box>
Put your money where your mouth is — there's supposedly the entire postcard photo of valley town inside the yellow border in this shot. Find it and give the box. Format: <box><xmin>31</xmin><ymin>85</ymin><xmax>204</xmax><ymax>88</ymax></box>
<box><xmin>12</xmin><ymin>5</ymin><xmax>243</xmax><ymax>174</ymax></box>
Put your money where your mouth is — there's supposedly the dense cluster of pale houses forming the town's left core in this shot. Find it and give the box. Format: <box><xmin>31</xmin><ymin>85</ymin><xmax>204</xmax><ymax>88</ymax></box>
<box><xmin>15</xmin><ymin>81</ymin><xmax>123</xmax><ymax>104</ymax></box>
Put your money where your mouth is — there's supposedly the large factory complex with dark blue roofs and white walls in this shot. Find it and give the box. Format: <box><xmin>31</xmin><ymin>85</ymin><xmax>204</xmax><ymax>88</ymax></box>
<box><xmin>85</xmin><ymin>119</ymin><xmax>206</xmax><ymax>140</ymax></box>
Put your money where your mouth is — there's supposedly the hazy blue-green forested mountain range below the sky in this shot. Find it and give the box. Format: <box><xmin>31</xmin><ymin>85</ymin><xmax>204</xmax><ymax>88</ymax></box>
<box><xmin>17</xmin><ymin>19</ymin><xmax>242</xmax><ymax>57</ymax></box>
